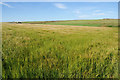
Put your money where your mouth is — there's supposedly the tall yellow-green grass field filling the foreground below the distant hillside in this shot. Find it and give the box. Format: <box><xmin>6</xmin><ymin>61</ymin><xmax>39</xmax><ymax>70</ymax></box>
<box><xmin>2</xmin><ymin>23</ymin><xmax>118</xmax><ymax>78</ymax></box>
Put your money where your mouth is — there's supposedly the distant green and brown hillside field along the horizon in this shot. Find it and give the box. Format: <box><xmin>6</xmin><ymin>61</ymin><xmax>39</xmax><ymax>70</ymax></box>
<box><xmin>24</xmin><ymin>19</ymin><xmax>118</xmax><ymax>27</ymax></box>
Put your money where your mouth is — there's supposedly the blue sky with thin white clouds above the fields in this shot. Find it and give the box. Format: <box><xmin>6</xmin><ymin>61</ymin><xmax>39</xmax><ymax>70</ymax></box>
<box><xmin>0</xmin><ymin>2</ymin><xmax>118</xmax><ymax>22</ymax></box>
